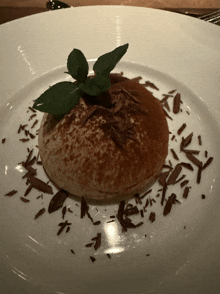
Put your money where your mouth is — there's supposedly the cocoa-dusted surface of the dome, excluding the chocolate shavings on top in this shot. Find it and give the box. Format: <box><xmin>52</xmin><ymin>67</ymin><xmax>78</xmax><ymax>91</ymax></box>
<box><xmin>39</xmin><ymin>77</ymin><xmax>168</xmax><ymax>198</ymax></box>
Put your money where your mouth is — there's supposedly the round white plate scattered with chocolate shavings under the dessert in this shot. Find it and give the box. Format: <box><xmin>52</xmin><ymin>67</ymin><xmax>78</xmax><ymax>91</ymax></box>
<box><xmin>0</xmin><ymin>6</ymin><xmax>220</xmax><ymax>294</ymax></box>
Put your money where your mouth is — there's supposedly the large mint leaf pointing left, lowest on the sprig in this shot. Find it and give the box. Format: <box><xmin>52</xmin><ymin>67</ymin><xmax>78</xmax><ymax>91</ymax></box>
<box><xmin>33</xmin><ymin>82</ymin><xmax>82</xmax><ymax>115</ymax></box>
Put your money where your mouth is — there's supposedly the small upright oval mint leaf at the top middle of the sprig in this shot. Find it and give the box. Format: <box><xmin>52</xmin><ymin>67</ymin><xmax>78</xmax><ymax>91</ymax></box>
<box><xmin>67</xmin><ymin>49</ymin><xmax>89</xmax><ymax>83</ymax></box>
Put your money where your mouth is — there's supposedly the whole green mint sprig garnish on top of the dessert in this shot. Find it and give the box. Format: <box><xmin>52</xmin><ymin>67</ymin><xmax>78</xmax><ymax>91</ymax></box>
<box><xmin>33</xmin><ymin>44</ymin><xmax>128</xmax><ymax>118</ymax></box>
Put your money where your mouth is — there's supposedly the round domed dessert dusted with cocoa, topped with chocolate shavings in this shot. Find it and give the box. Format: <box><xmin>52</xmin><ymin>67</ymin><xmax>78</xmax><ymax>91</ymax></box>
<box><xmin>38</xmin><ymin>74</ymin><xmax>169</xmax><ymax>199</ymax></box>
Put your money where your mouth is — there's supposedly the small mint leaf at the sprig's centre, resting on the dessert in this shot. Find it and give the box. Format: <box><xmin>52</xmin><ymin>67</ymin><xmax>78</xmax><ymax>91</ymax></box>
<box><xmin>79</xmin><ymin>76</ymin><xmax>111</xmax><ymax>96</ymax></box>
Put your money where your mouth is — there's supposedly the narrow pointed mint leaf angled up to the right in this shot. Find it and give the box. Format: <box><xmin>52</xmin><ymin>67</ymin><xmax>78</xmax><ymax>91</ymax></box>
<box><xmin>93</xmin><ymin>44</ymin><xmax>128</xmax><ymax>76</ymax></box>
